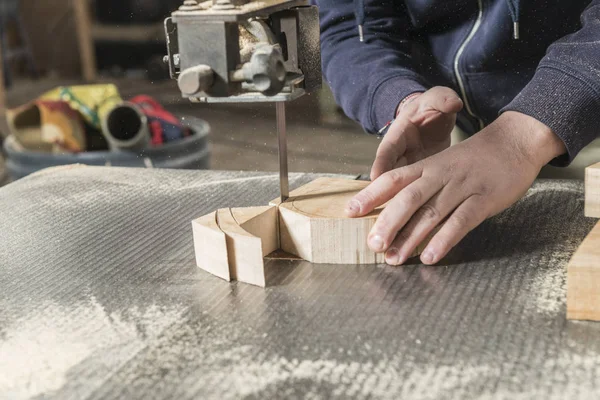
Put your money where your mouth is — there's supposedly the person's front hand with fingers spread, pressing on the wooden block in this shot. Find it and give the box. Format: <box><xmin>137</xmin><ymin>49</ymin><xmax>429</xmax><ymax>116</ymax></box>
<box><xmin>346</xmin><ymin>111</ymin><xmax>566</xmax><ymax>265</ymax></box>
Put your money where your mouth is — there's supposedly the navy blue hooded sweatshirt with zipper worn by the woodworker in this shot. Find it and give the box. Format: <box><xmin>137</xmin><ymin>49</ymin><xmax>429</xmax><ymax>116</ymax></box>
<box><xmin>317</xmin><ymin>0</ymin><xmax>600</xmax><ymax>165</ymax></box>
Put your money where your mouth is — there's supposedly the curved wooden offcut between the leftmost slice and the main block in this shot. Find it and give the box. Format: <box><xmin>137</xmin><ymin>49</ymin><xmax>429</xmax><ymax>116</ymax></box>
<box><xmin>217</xmin><ymin>206</ymin><xmax>278</xmax><ymax>287</ymax></box>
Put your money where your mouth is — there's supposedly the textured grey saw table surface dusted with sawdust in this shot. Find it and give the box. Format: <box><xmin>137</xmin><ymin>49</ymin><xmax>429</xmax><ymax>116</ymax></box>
<box><xmin>0</xmin><ymin>168</ymin><xmax>600</xmax><ymax>399</ymax></box>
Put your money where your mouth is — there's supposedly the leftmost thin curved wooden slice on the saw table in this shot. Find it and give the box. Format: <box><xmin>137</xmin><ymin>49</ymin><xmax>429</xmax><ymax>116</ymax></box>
<box><xmin>192</xmin><ymin>211</ymin><xmax>232</xmax><ymax>281</ymax></box>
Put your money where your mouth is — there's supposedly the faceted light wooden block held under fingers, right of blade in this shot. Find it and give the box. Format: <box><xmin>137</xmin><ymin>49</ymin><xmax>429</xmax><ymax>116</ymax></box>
<box><xmin>271</xmin><ymin>178</ymin><xmax>428</xmax><ymax>264</ymax></box>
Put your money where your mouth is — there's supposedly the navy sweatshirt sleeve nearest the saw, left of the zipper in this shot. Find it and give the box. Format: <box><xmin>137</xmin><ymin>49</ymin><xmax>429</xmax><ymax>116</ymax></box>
<box><xmin>318</xmin><ymin>0</ymin><xmax>428</xmax><ymax>133</ymax></box>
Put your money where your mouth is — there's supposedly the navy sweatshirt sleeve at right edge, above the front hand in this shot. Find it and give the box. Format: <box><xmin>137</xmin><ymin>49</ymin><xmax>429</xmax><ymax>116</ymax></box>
<box><xmin>500</xmin><ymin>0</ymin><xmax>600</xmax><ymax>166</ymax></box>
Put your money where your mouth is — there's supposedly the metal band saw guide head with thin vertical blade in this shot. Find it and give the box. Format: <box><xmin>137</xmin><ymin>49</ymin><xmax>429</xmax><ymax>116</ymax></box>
<box><xmin>165</xmin><ymin>0</ymin><xmax>322</xmax><ymax>200</ymax></box>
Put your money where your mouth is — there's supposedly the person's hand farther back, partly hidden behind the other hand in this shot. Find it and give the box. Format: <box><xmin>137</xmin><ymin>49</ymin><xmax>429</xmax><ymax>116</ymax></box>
<box><xmin>371</xmin><ymin>86</ymin><xmax>463</xmax><ymax>180</ymax></box>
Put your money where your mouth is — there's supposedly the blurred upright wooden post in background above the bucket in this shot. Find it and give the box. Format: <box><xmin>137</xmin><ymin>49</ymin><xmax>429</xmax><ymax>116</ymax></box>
<box><xmin>72</xmin><ymin>0</ymin><xmax>96</xmax><ymax>82</ymax></box>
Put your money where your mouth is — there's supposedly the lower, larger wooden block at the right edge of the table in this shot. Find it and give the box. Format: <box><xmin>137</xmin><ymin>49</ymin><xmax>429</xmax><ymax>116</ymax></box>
<box><xmin>567</xmin><ymin>222</ymin><xmax>600</xmax><ymax>321</ymax></box>
